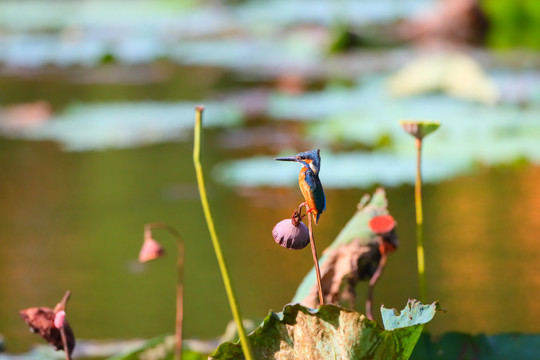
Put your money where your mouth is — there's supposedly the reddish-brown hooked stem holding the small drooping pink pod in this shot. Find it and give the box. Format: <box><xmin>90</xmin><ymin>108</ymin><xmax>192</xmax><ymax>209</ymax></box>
<box><xmin>144</xmin><ymin>223</ymin><xmax>184</xmax><ymax>360</ymax></box>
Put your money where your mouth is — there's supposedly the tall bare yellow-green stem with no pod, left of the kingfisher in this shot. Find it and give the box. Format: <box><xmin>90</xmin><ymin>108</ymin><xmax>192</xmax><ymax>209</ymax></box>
<box><xmin>193</xmin><ymin>106</ymin><xmax>254</xmax><ymax>360</ymax></box>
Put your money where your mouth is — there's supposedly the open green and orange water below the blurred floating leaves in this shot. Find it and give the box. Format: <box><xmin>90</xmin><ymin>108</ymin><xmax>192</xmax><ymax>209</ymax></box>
<box><xmin>0</xmin><ymin>131</ymin><xmax>540</xmax><ymax>351</ymax></box>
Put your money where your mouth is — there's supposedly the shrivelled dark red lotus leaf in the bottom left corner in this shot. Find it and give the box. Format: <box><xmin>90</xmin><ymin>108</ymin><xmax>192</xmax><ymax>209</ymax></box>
<box><xmin>19</xmin><ymin>307</ymin><xmax>75</xmax><ymax>355</ymax></box>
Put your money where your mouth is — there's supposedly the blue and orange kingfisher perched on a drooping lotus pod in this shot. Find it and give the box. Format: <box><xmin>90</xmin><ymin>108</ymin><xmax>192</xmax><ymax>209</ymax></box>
<box><xmin>274</xmin><ymin>149</ymin><xmax>326</xmax><ymax>224</ymax></box>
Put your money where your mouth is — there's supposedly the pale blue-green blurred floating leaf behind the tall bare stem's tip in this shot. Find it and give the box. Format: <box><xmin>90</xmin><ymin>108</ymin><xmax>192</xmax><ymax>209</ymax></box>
<box><xmin>0</xmin><ymin>101</ymin><xmax>243</xmax><ymax>151</ymax></box>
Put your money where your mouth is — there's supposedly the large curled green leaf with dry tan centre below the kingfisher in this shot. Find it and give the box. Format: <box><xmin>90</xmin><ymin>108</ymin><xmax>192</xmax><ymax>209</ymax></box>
<box><xmin>210</xmin><ymin>304</ymin><xmax>442</xmax><ymax>360</ymax></box>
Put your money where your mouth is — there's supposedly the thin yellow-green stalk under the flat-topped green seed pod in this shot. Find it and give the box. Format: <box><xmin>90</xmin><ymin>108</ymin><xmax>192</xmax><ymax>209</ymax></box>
<box><xmin>414</xmin><ymin>138</ymin><xmax>426</xmax><ymax>304</ymax></box>
